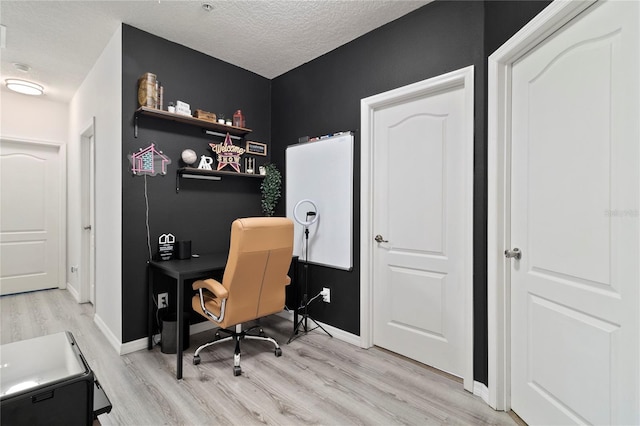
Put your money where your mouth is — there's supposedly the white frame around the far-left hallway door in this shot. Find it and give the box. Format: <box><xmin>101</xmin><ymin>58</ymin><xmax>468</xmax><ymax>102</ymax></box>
<box><xmin>0</xmin><ymin>136</ymin><xmax>67</xmax><ymax>290</ymax></box>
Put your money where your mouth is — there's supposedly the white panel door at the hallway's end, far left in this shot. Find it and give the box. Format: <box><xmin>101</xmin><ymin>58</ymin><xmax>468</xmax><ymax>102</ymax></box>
<box><xmin>0</xmin><ymin>140</ymin><xmax>61</xmax><ymax>295</ymax></box>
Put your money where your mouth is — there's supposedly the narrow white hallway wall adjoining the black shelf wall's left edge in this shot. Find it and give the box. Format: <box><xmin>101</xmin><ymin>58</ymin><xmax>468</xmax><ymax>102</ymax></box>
<box><xmin>67</xmin><ymin>27</ymin><xmax>122</xmax><ymax>353</ymax></box>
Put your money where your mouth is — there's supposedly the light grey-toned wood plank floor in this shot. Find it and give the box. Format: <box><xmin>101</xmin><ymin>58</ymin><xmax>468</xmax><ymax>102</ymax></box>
<box><xmin>0</xmin><ymin>290</ymin><xmax>516</xmax><ymax>425</ymax></box>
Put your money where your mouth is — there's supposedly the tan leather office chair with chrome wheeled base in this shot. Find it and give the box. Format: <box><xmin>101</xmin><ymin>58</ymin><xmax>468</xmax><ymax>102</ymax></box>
<box><xmin>191</xmin><ymin>217</ymin><xmax>293</xmax><ymax>376</ymax></box>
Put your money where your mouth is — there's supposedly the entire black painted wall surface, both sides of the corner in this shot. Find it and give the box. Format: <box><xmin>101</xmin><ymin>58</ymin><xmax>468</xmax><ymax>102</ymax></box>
<box><xmin>122</xmin><ymin>1</ymin><xmax>549</xmax><ymax>384</ymax></box>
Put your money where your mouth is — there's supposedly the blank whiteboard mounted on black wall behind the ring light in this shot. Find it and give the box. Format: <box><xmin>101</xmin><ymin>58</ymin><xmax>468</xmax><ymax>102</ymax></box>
<box><xmin>285</xmin><ymin>132</ymin><xmax>353</xmax><ymax>270</ymax></box>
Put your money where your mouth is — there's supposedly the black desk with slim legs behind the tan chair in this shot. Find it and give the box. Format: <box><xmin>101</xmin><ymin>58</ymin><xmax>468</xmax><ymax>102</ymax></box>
<box><xmin>147</xmin><ymin>252</ymin><xmax>299</xmax><ymax>379</ymax></box>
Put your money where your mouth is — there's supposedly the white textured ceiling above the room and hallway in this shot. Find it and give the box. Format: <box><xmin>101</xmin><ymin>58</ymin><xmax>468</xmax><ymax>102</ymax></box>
<box><xmin>0</xmin><ymin>0</ymin><xmax>431</xmax><ymax>102</ymax></box>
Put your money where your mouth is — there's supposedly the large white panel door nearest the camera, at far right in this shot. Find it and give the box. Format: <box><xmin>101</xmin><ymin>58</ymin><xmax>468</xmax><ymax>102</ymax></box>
<box><xmin>511</xmin><ymin>1</ymin><xmax>640</xmax><ymax>425</ymax></box>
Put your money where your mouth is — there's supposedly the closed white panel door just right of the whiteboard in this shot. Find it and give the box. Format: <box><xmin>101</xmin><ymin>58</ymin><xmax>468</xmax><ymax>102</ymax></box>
<box><xmin>370</xmin><ymin>68</ymin><xmax>473</xmax><ymax>377</ymax></box>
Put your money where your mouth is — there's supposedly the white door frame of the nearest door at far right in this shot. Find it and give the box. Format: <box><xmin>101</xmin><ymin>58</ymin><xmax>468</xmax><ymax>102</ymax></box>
<box><xmin>487</xmin><ymin>0</ymin><xmax>595</xmax><ymax>411</ymax></box>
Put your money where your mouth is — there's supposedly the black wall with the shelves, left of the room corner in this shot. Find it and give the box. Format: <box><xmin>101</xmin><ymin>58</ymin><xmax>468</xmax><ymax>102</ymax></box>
<box><xmin>121</xmin><ymin>25</ymin><xmax>271</xmax><ymax>342</ymax></box>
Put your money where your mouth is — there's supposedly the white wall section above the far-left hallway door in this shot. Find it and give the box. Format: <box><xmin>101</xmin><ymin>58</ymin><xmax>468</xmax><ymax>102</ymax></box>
<box><xmin>0</xmin><ymin>89</ymin><xmax>69</xmax><ymax>145</ymax></box>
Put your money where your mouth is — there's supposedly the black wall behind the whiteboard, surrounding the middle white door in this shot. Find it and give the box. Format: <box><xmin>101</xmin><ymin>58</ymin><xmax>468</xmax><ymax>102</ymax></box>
<box><xmin>272</xmin><ymin>1</ymin><xmax>549</xmax><ymax>384</ymax></box>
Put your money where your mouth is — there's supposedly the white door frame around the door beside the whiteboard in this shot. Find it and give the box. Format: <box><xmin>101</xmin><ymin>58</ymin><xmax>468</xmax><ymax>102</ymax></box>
<box><xmin>360</xmin><ymin>65</ymin><xmax>474</xmax><ymax>392</ymax></box>
